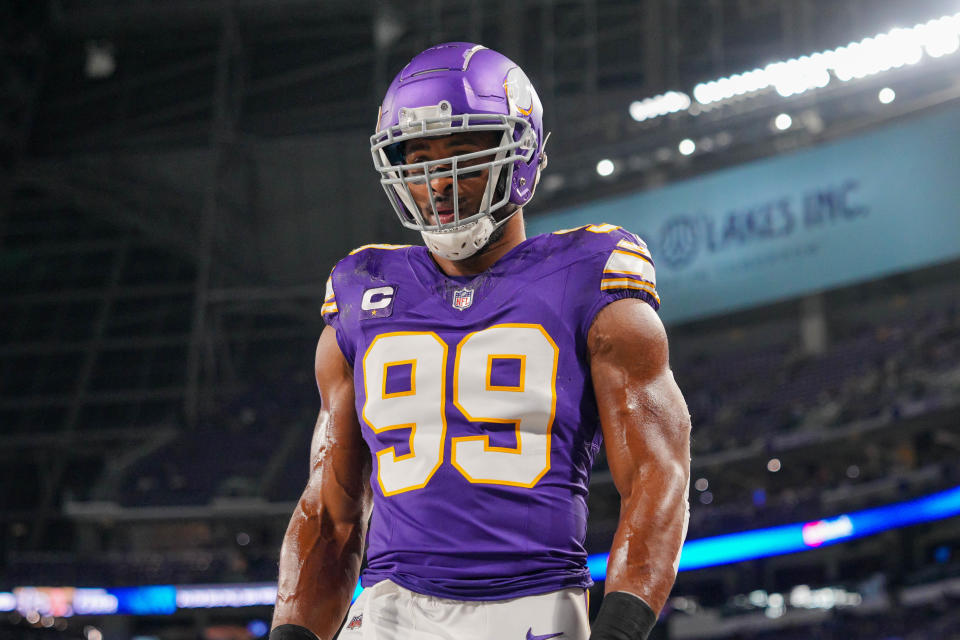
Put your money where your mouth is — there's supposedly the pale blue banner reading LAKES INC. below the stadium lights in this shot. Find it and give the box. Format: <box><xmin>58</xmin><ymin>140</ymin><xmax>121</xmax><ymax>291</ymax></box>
<box><xmin>527</xmin><ymin>108</ymin><xmax>960</xmax><ymax>322</ymax></box>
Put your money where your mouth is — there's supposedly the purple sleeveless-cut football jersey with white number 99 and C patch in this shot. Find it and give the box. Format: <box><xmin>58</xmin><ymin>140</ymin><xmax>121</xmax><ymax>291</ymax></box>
<box><xmin>323</xmin><ymin>225</ymin><xmax>659</xmax><ymax>600</ymax></box>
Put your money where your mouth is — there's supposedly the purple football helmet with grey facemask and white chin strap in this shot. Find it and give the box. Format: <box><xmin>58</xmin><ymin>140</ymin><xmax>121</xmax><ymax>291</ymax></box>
<box><xmin>370</xmin><ymin>42</ymin><xmax>547</xmax><ymax>260</ymax></box>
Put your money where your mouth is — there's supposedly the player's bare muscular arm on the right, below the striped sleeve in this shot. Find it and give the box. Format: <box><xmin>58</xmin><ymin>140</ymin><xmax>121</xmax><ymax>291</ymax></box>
<box><xmin>587</xmin><ymin>298</ymin><xmax>690</xmax><ymax>612</ymax></box>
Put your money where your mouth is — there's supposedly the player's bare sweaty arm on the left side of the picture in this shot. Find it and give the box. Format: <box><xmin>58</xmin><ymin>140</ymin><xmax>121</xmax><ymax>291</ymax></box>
<box><xmin>273</xmin><ymin>327</ymin><xmax>371</xmax><ymax>640</ymax></box>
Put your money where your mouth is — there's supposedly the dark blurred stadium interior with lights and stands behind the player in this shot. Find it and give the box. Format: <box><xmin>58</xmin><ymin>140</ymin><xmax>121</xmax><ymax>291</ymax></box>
<box><xmin>0</xmin><ymin>0</ymin><xmax>960</xmax><ymax>640</ymax></box>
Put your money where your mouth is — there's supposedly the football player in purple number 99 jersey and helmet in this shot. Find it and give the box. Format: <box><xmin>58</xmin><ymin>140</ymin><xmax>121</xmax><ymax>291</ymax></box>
<box><xmin>270</xmin><ymin>43</ymin><xmax>690</xmax><ymax>640</ymax></box>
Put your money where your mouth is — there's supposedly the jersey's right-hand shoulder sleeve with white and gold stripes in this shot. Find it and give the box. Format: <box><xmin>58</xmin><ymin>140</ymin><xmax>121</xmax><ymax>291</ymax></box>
<box><xmin>584</xmin><ymin>225</ymin><xmax>660</xmax><ymax>330</ymax></box>
